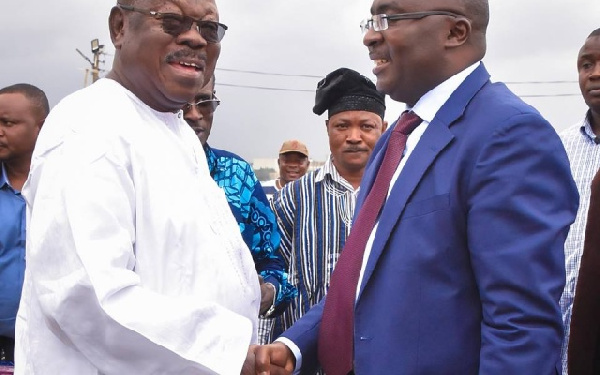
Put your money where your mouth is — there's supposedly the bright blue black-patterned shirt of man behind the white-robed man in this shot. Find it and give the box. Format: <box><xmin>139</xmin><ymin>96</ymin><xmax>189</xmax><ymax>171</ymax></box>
<box><xmin>204</xmin><ymin>144</ymin><xmax>297</xmax><ymax>315</ymax></box>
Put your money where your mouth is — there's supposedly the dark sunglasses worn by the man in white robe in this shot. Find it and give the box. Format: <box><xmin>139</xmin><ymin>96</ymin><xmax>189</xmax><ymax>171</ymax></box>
<box><xmin>117</xmin><ymin>4</ymin><xmax>227</xmax><ymax>44</ymax></box>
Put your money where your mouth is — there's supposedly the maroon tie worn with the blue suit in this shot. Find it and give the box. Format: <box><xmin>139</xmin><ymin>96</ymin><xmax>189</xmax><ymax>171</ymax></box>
<box><xmin>318</xmin><ymin>112</ymin><xmax>421</xmax><ymax>375</ymax></box>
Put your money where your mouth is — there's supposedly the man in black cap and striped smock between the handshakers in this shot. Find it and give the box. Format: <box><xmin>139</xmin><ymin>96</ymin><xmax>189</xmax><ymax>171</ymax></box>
<box><xmin>272</xmin><ymin>68</ymin><xmax>387</xmax><ymax>356</ymax></box>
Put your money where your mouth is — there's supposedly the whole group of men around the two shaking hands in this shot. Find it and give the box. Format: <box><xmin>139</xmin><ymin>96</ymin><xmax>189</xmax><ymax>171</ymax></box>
<box><xmin>0</xmin><ymin>0</ymin><xmax>600</xmax><ymax>375</ymax></box>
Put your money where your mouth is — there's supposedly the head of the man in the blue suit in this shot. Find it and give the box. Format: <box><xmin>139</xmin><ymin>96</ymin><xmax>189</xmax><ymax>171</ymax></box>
<box><xmin>363</xmin><ymin>0</ymin><xmax>489</xmax><ymax>105</ymax></box>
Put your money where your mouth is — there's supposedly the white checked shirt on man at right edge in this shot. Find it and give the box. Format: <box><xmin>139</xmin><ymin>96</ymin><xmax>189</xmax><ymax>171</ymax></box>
<box><xmin>560</xmin><ymin>112</ymin><xmax>600</xmax><ymax>375</ymax></box>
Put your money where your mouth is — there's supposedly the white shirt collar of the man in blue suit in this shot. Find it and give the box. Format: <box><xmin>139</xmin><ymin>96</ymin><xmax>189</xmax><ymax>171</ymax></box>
<box><xmin>407</xmin><ymin>61</ymin><xmax>481</xmax><ymax>123</ymax></box>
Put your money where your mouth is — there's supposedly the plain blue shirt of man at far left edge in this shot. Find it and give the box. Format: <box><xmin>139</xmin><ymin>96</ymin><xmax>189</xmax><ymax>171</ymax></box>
<box><xmin>0</xmin><ymin>164</ymin><xmax>25</xmax><ymax>337</ymax></box>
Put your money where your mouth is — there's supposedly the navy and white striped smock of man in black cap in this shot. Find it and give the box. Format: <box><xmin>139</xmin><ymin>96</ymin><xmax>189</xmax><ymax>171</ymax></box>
<box><xmin>271</xmin><ymin>157</ymin><xmax>358</xmax><ymax>339</ymax></box>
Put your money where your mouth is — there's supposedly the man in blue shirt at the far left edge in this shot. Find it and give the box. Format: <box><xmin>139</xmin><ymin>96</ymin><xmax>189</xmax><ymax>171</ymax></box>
<box><xmin>0</xmin><ymin>83</ymin><xmax>49</xmax><ymax>361</ymax></box>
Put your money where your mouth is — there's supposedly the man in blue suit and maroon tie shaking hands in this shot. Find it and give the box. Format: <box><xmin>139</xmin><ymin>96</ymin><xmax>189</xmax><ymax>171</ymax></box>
<box><xmin>243</xmin><ymin>0</ymin><xmax>578</xmax><ymax>375</ymax></box>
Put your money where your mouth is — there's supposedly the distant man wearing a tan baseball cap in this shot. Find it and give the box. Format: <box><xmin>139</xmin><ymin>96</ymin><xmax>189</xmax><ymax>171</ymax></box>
<box><xmin>262</xmin><ymin>139</ymin><xmax>310</xmax><ymax>200</ymax></box>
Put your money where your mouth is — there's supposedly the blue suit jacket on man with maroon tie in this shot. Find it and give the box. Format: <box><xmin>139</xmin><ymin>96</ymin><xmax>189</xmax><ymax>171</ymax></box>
<box><xmin>283</xmin><ymin>64</ymin><xmax>579</xmax><ymax>375</ymax></box>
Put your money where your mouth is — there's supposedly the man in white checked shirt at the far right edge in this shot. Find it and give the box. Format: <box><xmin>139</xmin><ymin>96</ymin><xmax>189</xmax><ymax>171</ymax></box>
<box><xmin>560</xmin><ymin>29</ymin><xmax>600</xmax><ymax>375</ymax></box>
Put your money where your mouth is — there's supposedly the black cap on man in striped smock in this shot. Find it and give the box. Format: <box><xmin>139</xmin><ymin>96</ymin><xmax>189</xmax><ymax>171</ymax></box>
<box><xmin>313</xmin><ymin>68</ymin><xmax>385</xmax><ymax>119</ymax></box>
